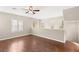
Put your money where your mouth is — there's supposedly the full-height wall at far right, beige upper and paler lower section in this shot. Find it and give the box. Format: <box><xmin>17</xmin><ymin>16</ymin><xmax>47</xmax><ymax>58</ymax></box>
<box><xmin>64</xmin><ymin>6</ymin><xmax>79</xmax><ymax>42</ymax></box>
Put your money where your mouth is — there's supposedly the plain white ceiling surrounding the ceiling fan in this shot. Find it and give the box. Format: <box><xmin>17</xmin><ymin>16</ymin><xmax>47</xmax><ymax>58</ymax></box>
<box><xmin>0</xmin><ymin>6</ymin><xmax>73</xmax><ymax>19</ymax></box>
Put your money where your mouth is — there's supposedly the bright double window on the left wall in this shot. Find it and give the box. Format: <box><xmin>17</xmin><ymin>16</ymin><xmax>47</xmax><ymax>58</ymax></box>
<box><xmin>11</xmin><ymin>19</ymin><xmax>23</xmax><ymax>33</ymax></box>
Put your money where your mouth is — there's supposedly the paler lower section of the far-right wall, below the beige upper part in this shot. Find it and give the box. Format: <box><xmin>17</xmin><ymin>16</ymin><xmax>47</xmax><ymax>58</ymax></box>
<box><xmin>64</xmin><ymin>21</ymin><xmax>79</xmax><ymax>42</ymax></box>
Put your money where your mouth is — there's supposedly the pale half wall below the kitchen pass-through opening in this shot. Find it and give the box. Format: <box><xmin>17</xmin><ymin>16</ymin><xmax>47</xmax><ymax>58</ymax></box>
<box><xmin>33</xmin><ymin>29</ymin><xmax>64</xmax><ymax>42</ymax></box>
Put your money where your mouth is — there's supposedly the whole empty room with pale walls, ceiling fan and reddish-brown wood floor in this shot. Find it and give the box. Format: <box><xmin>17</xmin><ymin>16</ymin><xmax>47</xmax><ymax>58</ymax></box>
<box><xmin>0</xmin><ymin>6</ymin><xmax>79</xmax><ymax>52</ymax></box>
